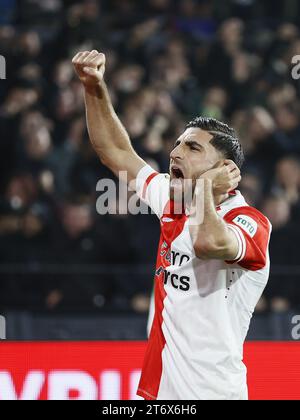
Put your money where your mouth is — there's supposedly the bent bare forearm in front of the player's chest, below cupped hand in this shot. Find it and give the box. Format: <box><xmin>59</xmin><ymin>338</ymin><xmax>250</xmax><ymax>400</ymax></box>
<box><xmin>190</xmin><ymin>179</ymin><xmax>238</xmax><ymax>259</ymax></box>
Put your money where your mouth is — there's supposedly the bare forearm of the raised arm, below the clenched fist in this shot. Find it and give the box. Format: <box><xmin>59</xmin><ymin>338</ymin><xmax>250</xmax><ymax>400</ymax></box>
<box><xmin>85</xmin><ymin>81</ymin><xmax>134</xmax><ymax>163</ymax></box>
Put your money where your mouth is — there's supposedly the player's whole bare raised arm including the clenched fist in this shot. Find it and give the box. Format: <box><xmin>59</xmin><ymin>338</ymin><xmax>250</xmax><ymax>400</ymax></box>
<box><xmin>73</xmin><ymin>50</ymin><xmax>146</xmax><ymax>182</ymax></box>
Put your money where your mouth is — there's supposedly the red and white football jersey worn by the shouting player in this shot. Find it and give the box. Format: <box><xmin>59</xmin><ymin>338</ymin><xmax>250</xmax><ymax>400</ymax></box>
<box><xmin>136</xmin><ymin>165</ymin><xmax>271</xmax><ymax>400</ymax></box>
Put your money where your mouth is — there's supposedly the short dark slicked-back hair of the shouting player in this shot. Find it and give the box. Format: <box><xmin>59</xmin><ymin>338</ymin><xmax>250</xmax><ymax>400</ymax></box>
<box><xmin>185</xmin><ymin>117</ymin><xmax>245</xmax><ymax>169</ymax></box>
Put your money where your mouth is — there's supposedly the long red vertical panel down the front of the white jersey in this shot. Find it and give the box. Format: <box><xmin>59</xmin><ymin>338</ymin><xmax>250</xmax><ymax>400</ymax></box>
<box><xmin>137</xmin><ymin>201</ymin><xmax>187</xmax><ymax>400</ymax></box>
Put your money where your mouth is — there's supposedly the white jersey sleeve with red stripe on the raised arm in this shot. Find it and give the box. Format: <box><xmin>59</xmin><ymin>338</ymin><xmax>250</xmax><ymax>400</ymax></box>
<box><xmin>136</xmin><ymin>165</ymin><xmax>170</xmax><ymax>218</ymax></box>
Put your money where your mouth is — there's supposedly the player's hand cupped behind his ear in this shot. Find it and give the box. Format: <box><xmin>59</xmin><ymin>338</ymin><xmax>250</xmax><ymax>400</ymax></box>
<box><xmin>200</xmin><ymin>160</ymin><xmax>242</xmax><ymax>195</ymax></box>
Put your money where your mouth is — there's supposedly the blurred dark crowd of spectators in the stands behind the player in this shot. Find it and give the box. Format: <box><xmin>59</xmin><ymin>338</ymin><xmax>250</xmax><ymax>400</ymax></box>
<box><xmin>0</xmin><ymin>0</ymin><xmax>300</xmax><ymax>312</ymax></box>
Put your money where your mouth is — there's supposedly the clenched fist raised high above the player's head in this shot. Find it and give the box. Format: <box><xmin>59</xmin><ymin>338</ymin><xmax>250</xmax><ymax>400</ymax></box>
<box><xmin>72</xmin><ymin>50</ymin><xmax>105</xmax><ymax>88</ymax></box>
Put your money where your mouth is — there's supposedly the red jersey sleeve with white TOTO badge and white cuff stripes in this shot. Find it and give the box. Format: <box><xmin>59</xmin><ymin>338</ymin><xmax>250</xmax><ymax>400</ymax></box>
<box><xmin>224</xmin><ymin>206</ymin><xmax>271</xmax><ymax>271</ymax></box>
